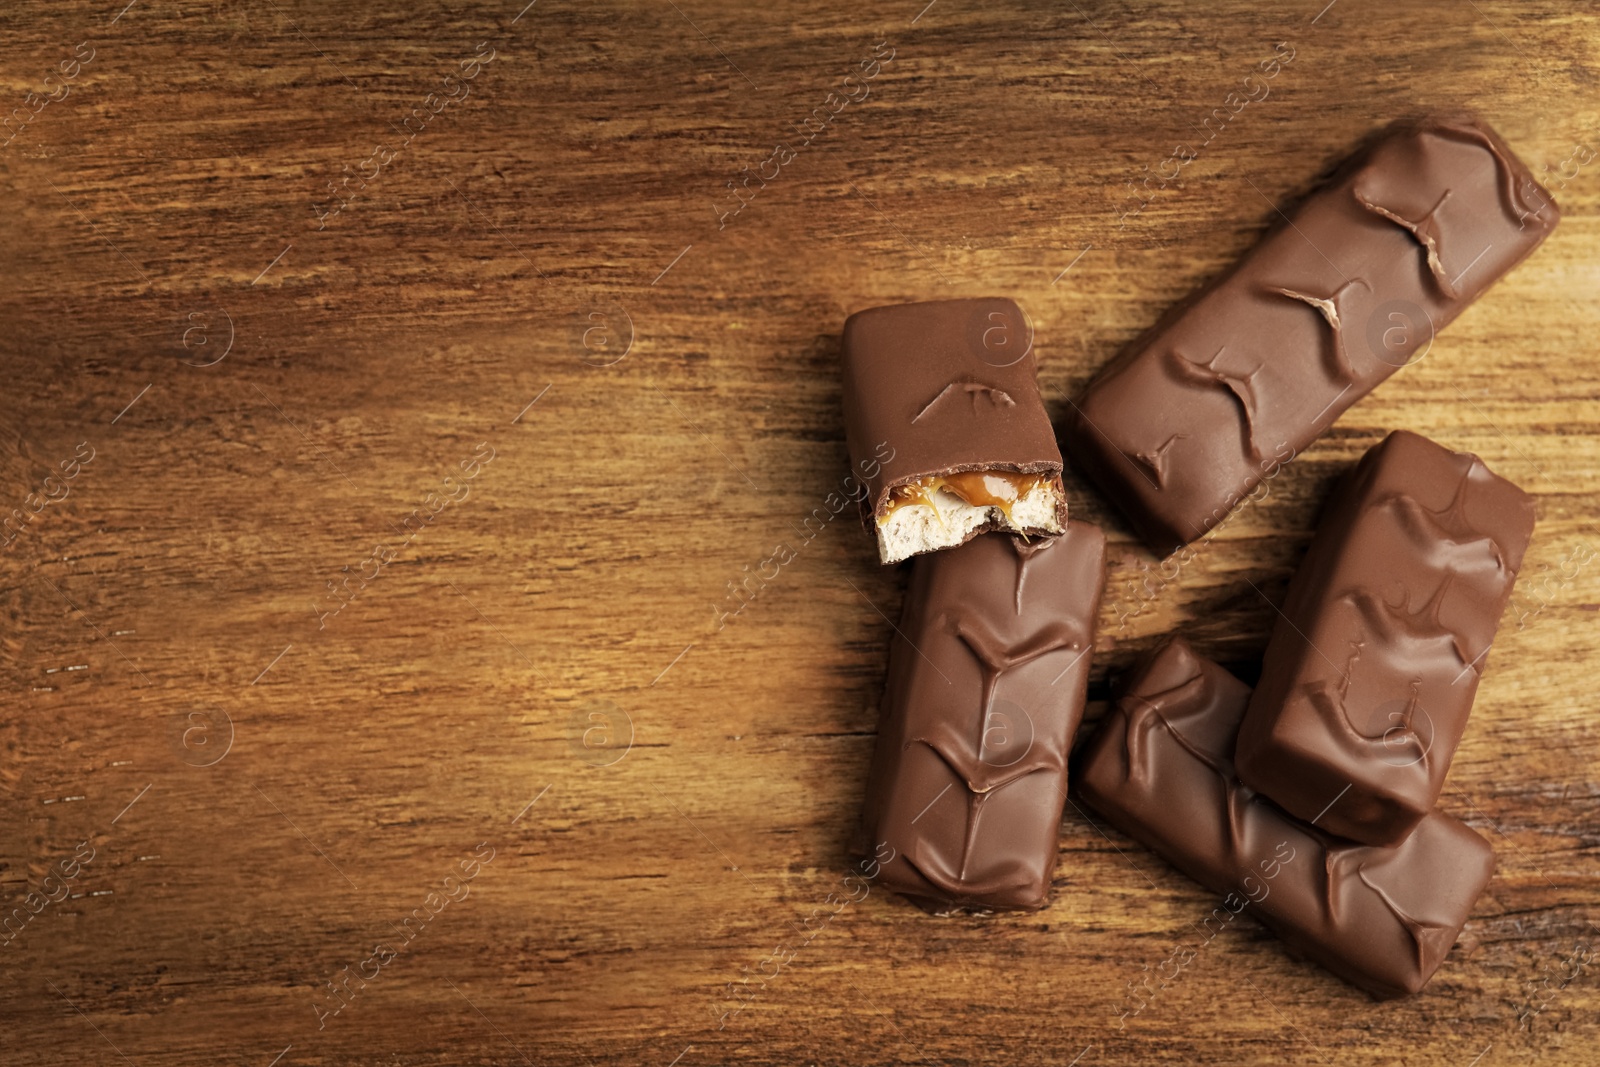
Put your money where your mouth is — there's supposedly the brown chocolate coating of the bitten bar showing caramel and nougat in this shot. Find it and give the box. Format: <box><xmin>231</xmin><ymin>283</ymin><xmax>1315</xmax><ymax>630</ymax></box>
<box><xmin>843</xmin><ymin>298</ymin><xmax>1067</xmax><ymax>559</ymax></box>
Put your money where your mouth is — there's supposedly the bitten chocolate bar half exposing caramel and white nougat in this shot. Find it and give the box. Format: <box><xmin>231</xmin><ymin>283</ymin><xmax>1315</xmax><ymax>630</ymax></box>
<box><xmin>843</xmin><ymin>298</ymin><xmax>1067</xmax><ymax>563</ymax></box>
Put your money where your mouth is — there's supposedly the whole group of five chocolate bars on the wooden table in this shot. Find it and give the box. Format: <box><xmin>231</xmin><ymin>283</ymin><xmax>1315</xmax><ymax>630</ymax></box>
<box><xmin>843</xmin><ymin>117</ymin><xmax>1558</xmax><ymax>997</ymax></box>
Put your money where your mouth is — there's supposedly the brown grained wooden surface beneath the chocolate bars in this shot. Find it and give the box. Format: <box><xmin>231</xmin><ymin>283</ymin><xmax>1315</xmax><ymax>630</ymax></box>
<box><xmin>0</xmin><ymin>0</ymin><xmax>1600</xmax><ymax>1067</ymax></box>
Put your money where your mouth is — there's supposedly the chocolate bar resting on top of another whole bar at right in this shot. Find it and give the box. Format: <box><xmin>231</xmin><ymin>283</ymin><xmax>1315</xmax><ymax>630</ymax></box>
<box><xmin>1237</xmin><ymin>430</ymin><xmax>1533</xmax><ymax>845</ymax></box>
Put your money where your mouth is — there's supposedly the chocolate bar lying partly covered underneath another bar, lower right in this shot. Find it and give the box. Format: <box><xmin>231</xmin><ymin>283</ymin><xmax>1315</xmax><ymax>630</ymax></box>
<box><xmin>1077</xmin><ymin>640</ymin><xmax>1494</xmax><ymax>997</ymax></box>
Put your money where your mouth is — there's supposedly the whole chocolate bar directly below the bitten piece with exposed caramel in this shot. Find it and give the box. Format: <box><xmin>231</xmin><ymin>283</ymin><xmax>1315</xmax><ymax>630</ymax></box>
<box><xmin>862</xmin><ymin>523</ymin><xmax>1106</xmax><ymax>912</ymax></box>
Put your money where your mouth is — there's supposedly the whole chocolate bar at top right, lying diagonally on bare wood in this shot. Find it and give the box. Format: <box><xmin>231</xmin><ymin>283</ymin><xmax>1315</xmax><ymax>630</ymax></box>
<box><xmin>1062</xmin><ymin>118</ymin><xmax>1560</xmax><ymax>553</ymax></box>
